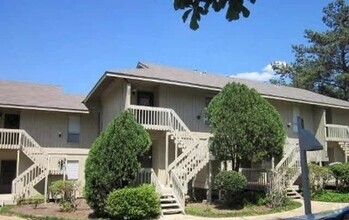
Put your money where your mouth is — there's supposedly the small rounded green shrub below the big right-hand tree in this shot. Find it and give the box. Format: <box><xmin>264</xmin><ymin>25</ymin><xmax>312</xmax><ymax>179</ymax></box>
<box><xmin>214</xmin><ymin>170</ymin><xmax>247</xmax><ymax>205</ymax></box>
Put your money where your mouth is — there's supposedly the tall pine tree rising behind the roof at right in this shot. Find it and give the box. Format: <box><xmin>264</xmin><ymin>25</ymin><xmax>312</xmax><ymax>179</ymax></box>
<box><xmin>272</xmin><ymin>0</ymin><xmax>349</xmax><ymax>101</ymax></box>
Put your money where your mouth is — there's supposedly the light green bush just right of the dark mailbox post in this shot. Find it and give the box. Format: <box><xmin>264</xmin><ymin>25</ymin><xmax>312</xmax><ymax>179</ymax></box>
<box><xmin>309</xmin><ymin>163</ymin><xmax>333</xmax><ymax>193</ymax></box>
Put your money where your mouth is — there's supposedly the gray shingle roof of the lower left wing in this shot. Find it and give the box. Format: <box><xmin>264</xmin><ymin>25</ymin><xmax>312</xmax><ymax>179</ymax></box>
<box><xmin>0</xmin><ymin>80</ymin><xmax>88</xmax><ymax>112</ymax></box>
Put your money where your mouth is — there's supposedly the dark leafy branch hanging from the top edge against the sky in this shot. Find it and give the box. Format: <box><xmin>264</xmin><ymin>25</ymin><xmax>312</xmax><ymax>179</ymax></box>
<box><xmin>173</xmin><ymin>0</ymin><xmax>256</xmax><ymax>30</ymax></box>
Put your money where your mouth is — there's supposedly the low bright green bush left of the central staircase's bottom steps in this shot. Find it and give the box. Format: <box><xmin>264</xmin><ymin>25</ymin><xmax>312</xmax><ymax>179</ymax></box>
<box><xmin>106</xmin><ymin>184</ymin><xmax>160</xmax><ymax>219</ymax></box>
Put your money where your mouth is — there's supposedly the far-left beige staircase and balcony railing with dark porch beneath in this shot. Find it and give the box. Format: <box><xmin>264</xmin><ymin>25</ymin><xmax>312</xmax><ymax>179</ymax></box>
<box><xmin>0</xmin><ymin>128</ymin><xmax>67</xmax><ymax>198</ymax></box>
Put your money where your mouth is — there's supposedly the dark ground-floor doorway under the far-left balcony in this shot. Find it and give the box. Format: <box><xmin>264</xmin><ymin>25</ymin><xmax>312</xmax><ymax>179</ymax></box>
<box><xmin>0</xmin><ymin>160</ymin><xmax>16</xmax><ymax>193</ymax></box>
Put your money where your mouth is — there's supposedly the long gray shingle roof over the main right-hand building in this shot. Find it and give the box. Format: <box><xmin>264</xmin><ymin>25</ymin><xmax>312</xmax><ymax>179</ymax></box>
<box><xmin>107</xmin><ymin>62</ymin><xmax>349</xmax><ymax>109</ymax></box>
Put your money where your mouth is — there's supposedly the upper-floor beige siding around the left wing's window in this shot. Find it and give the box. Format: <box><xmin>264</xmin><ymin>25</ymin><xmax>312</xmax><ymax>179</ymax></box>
<box><xmin>20</xmin><ymin>110</ymin><xmax>98</xmax><ymax>148</ymax></box>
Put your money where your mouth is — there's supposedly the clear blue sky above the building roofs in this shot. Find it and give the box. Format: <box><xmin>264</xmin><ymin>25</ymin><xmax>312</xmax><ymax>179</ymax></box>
<box><xmin>0</xmin><ymin>0</ymin><xmax>336</xmax><ymax>94</ymax></box>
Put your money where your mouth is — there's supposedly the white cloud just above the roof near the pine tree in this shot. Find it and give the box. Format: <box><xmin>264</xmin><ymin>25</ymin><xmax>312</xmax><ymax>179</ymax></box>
<box><xmin>231</xmin><ymin>61</ymin><xmax>286</xmax><ymax>82</ymax></box>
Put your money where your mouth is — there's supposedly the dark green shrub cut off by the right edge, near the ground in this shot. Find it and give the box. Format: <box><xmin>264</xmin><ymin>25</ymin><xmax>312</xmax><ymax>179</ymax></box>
<box><xmin>329</xmin><ymin>163</ymin><xmax>349</xmax><ymax>190</ymax></box>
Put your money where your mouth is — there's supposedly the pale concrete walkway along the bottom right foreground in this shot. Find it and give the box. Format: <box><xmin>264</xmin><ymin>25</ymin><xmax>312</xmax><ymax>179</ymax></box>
<box><xmin>161</xmin><ymin>200</ymin><xmax>349</xmax><ymax>220</ymax></box>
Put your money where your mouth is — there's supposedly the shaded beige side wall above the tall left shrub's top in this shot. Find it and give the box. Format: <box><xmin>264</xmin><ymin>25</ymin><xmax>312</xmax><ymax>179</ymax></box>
<box><xmin>101</xmin><ymin>80</ymin><xmax>126</xmax><ymax>130</ymax></box>
